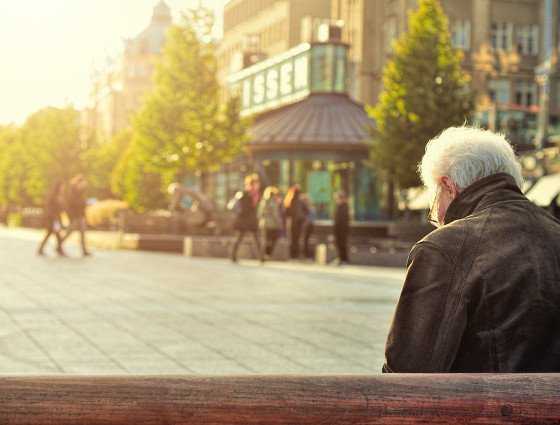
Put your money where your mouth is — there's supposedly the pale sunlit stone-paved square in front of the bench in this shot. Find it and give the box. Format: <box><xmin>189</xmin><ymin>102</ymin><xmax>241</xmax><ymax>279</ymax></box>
<box><xmin>0</xmin><ymin>227</ymin><xmax>404</xmax><ymax>374</ymax></box>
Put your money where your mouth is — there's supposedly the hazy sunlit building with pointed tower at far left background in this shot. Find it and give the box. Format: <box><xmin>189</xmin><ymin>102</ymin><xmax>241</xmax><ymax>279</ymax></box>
<box><xmin>85</xmin><ymin>0</ymin><xmax>172</xmax><ymax>140</ymax></box>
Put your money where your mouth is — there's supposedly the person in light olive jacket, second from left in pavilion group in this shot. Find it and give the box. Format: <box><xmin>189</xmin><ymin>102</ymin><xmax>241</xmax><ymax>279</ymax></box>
<box><xmin>257</xmin><ymin>186</ymin><xmax>283</xmax><ymax>260</ymax></box>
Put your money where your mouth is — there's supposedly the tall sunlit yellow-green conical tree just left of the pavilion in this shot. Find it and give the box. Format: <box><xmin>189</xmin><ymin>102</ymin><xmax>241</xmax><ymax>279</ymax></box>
<box><xmin>132</xmin><ymin>5</ymin><xmax>246</xmax><ymax>200</ymax></box>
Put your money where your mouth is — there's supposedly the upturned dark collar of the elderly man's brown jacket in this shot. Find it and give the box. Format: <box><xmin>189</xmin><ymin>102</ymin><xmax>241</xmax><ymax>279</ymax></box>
<box><xmin>443</xmin><ymin>173</ymin><xmax>526</xmax><ymax>224</ymax></box>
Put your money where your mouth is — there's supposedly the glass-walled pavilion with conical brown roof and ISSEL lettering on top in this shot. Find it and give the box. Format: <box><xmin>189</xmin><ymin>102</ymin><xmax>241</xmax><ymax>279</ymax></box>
<box><xmin>200</xmin><ymin>43</ymin><xmax>383</xmax><ymax>220</ymax></box>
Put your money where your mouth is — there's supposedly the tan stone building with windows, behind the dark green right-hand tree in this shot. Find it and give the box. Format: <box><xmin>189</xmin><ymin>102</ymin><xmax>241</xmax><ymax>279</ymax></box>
<box><xmin>331</xmin><ymin>0</ymin><xmax>560</xmax><ymax>145</ymax></box>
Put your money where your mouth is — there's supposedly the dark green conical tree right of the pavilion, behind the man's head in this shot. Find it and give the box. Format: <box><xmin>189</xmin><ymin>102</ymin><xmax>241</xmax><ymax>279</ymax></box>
<box><xmin>366</xmin><ymin>0</ymin><xmax>474</xmax><ymax>216</ymax></box>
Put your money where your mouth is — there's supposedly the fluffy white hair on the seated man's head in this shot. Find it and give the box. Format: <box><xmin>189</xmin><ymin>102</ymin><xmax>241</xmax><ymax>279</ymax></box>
<box><xmin>418</xmin><ymin>126</ymin><xmax>523</xmax><ymax>193</ymax></box>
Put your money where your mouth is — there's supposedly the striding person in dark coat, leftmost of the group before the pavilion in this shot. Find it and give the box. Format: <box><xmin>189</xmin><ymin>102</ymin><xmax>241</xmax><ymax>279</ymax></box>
<box><xmin>230</xmin><ymin>174</ymin><xmax>264</xmax><ymax>263</ymax></box>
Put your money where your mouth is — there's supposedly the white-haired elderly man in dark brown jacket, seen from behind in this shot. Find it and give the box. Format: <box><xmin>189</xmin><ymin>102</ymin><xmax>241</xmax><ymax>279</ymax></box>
<box><xmin>383</xmin><ymin>127</ymin><xmax>560</xmax><ymax>373</ymax></box>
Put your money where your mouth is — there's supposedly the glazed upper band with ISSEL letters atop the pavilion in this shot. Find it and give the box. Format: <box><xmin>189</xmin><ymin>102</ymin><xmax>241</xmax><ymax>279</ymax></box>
<box><xmin>228</xmin><ymin>43</ymin><xmax>346</xmax><ymax>116</ymax></box>
